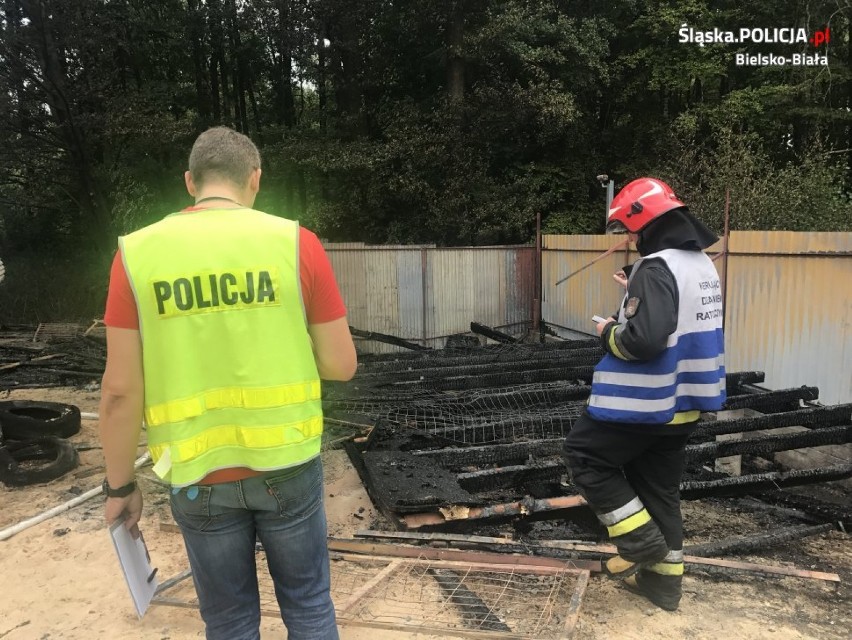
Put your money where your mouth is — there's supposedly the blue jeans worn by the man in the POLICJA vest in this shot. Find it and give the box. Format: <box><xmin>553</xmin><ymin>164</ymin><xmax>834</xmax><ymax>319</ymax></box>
<box><xmin>171</xmin><ymin>458</ymin><xmax>338</xmax><ymax>640</ymax></box>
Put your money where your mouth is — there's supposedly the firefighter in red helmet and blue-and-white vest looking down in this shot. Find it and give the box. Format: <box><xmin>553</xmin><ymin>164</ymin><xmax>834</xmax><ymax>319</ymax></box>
<box><xmin>564</xmin><ymin>178</ymin><xmax>725</xmax><ymax>611</ymax></box>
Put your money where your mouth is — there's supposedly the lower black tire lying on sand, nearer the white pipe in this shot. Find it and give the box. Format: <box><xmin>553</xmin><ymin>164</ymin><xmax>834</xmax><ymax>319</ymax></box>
<box><xmin>0</xmin><ymin>436</ymin><xmax>80</xmax><ymax>487</ymax></box>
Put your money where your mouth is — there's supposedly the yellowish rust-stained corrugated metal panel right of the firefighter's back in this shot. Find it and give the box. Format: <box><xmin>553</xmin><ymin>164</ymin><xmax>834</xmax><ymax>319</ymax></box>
<box><xmin>725</xmin><ymin>231</ymin><xmax>852</xmax><ymax>404</ymax></box>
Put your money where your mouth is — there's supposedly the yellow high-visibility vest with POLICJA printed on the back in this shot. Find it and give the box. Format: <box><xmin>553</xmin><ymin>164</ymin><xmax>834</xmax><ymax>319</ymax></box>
<box><xmin>119</xmin><ymin>209</ymin><xmax>323</xmax><ymax>487</ymax></box>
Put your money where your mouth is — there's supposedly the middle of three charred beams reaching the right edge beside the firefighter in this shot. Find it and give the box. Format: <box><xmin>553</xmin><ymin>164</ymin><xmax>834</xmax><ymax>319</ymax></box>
<box><xmin>686</xmin><ymin>425</ymin><xmax>852</xmax><ymax>464</ymax></box>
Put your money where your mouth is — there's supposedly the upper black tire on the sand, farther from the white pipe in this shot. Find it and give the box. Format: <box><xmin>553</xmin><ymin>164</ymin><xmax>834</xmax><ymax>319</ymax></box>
<box><xmin>0</xmin><ymin>400</ymin><xmax>80</xmax><ymax>440</ymax></box>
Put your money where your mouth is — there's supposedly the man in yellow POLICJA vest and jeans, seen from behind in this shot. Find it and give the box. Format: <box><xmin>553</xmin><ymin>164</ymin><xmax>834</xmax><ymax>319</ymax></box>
<box><xmin>100</xmin><ymin>127</ymin><xmax>356</xmax><ymax>640</ymax></box>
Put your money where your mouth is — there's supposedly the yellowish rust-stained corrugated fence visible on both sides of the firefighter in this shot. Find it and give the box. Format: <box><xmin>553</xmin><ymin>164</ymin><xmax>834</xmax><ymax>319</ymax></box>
<box><xmin>542</xmin><ymin>231</ymin><xmax>852</xmax><ymax>404</ymax></box>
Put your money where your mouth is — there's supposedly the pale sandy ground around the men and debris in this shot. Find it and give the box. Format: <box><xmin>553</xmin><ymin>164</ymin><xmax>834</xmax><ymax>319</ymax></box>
<box><xmin>0</xmin><ymin>389</ymin><xmax>852</xmax><ymax>640</ymax></box>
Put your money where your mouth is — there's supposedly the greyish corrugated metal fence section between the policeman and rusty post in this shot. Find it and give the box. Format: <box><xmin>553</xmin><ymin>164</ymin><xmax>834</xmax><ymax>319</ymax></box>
<box><xmin>325</xmin><ymin>244</ymin><xmax>535</xmax><ymax>352</ymax></box>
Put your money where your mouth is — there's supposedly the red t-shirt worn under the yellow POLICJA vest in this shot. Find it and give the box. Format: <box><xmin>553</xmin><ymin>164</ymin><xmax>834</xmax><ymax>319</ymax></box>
<box><xmin>104</xmin><ymin>207</ymin><xmax>346</xmax><ymax>484</ymax></box>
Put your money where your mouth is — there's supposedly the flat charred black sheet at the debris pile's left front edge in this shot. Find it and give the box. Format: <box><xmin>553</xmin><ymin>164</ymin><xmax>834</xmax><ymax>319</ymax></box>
<box><xmin>362</xmin><ymin>451</ymin><xmax>484</xmax><ymax>513</ymax></box>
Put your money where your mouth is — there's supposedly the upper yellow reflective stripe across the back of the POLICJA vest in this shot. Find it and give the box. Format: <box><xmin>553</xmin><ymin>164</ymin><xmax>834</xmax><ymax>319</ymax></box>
<box><xmin>145</xmin><ymin>380</ymin><xmax>322</xmax><ymax>427</ymax></box>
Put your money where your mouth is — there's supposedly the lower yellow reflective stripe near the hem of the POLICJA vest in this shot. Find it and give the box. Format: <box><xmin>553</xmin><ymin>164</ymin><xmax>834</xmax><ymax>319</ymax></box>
<box><xmin>149</xmin><ymin>416</ymin><xmax>323</xmax><ymax>466</ymax></box>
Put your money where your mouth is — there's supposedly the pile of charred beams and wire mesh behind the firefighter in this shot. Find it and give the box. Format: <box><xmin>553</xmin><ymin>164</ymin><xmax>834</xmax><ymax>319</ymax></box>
<box><xmin>324</xmin><ymin>331</ymin><xmax>852</xmax><ymax>539</ymax></box>
